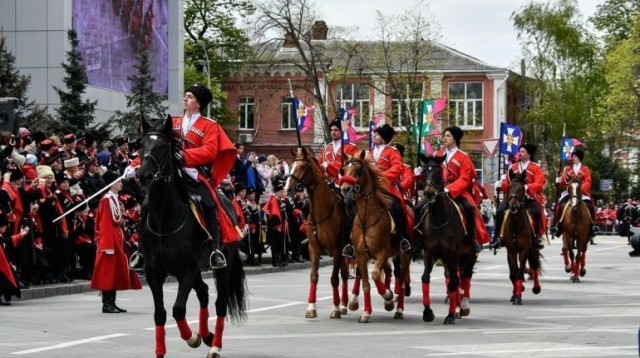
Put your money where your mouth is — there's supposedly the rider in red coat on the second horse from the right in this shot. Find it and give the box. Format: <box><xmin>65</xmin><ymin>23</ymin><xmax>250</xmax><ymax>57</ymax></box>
<box><xmin>492</xmin><ymin>143</ymin><xmax>547</xmax><ymax>250</ymax></box>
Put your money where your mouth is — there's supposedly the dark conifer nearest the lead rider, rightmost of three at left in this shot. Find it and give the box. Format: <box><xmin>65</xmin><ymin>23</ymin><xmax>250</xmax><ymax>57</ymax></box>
<box><xmin>110</xmin><ymin>51</ymin><xmax>168</xmax><ymax>137</ymax></box>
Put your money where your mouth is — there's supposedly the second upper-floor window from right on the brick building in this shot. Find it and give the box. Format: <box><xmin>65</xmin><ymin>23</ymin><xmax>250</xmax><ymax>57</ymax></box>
<box><xmin>391</xmin><ymin>82</ymin><xmax>422</xmax><ymax>127</ymax></box>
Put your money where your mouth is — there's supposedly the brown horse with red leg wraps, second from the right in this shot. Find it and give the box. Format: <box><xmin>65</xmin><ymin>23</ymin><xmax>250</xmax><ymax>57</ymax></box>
<box><xmin>496</xmin><ymin>171</ymin><xmax>542</xmax><ymax>305</ymax></box>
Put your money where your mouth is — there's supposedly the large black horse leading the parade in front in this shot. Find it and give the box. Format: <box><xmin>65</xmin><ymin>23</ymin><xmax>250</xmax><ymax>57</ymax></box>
<box><xmin>137</xmin><ymin>116</ymin><xmax>247</xmax><ymax>358</ymax></box>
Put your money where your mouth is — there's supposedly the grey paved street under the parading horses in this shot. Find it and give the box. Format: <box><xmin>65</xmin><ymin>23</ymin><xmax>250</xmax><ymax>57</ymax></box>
<box><xmin>0</xmin><ymin>236</ymin><xmax>640</xmax><ymax>358</ymax></box>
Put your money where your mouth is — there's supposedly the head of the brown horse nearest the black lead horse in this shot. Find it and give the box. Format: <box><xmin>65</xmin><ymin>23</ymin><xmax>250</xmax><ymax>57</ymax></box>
<box><xmin>284</xmin><ymin>147</ymin><xmax>323</xmax><ymax>196</ymax></box>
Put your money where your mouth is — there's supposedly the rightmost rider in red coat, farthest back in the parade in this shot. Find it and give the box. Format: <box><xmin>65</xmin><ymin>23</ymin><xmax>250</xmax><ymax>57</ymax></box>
<box><xmin>551</xmin><ymin>149</ymin><xmax>599</xmax><ymax>237</ymax></box>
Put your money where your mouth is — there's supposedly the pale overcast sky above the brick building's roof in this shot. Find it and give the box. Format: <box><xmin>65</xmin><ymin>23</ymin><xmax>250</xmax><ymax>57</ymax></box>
<box><xmin>315</xmin><ymin>0</ymin><xmax>605</xmax><ymax>69</ymax></box>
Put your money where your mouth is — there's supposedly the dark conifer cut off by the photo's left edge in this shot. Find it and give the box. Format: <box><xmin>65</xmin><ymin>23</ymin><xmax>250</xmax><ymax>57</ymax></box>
<box><xmin>0</xmin><ymin>32</ymin><xmax>51</xmax><ymax>130</ymax></box>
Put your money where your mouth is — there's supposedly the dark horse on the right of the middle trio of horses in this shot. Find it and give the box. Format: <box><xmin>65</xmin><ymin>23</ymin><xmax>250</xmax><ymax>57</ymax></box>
<box><xmin>415</xmin><ymin>155</ymin><xmax>477</xmax><ymax>324</ymax></box>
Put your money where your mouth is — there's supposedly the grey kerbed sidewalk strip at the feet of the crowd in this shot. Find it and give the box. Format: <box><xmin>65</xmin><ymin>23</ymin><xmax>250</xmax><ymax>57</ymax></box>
<box><xmin>13</xmin><ymin>253</ymin><xmax>332</xmax><ymax>300</ymax></box>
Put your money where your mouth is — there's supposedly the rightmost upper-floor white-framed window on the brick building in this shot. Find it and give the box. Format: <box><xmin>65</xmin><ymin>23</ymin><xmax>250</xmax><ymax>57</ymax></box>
<box><xmin>449</xmin><ymin>82</ymin><xmax>483</xmax><ymax>128</ymax></box>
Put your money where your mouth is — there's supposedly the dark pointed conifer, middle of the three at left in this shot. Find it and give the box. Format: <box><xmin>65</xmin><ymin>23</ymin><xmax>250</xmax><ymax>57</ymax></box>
<box><xmin>53</xmin><ymin>29</ymin><xmax>98</xmax><ymax>131</ymax></box>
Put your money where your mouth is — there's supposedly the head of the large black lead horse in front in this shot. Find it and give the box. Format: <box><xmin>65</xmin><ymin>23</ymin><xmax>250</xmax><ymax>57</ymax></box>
<box><xmin>136</xmin><ymin>115</ymin><xmax>181</xmax><ymax>188</ymax></box>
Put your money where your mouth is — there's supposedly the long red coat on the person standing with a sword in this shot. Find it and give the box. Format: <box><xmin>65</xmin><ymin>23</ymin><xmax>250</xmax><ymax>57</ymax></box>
<box><xmin>91</xmin><ymin>191</ymin><xmax>142</xmax><ymax>291</ymax></box>
